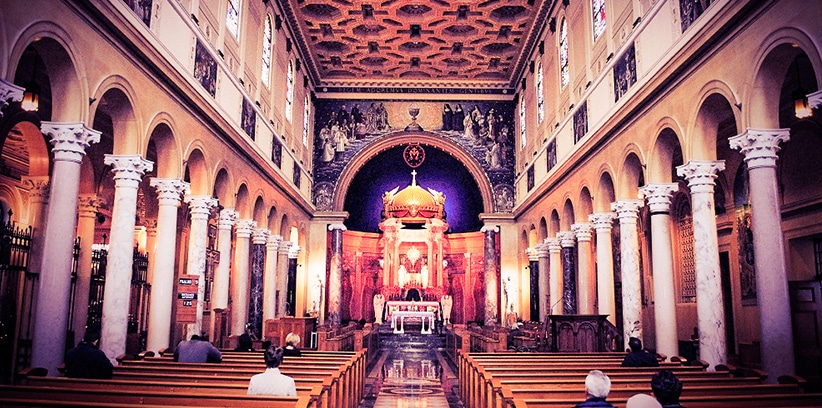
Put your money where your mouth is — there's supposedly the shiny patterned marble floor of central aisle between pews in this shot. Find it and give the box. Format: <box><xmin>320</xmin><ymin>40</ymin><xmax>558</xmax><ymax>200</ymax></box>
<box><xmin>360</xmin><ymin>347</ymin><xmax>463</xmax><ymax>408</ymax></box>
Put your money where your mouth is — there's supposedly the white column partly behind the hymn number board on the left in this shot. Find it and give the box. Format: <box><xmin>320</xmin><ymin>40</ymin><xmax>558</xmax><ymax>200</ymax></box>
<box><xmin>183</xmin><ymin>195</ymin><xmax>217</xmax><ymax>339</ymax></box>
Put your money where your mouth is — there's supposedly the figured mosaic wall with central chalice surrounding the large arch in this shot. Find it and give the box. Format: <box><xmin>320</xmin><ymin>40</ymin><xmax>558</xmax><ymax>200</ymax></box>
<box><xmin>313</xmin><ymin>100</ymin><xmax>516</xmax><ymax>218</ymax></box>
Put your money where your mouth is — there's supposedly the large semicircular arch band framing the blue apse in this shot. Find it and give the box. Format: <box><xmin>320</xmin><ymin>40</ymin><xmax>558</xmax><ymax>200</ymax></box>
<box><xmin>332</xmin><ymin>132</ymin><xmax>494</xmax><ymax>212</ymax></box>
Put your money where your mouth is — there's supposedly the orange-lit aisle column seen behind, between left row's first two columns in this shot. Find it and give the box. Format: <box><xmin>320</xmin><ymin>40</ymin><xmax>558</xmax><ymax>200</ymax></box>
<box><xmin>72</xmin><ymin>194</ymin><xmax>101</xmax><ymax>336</ymax></box>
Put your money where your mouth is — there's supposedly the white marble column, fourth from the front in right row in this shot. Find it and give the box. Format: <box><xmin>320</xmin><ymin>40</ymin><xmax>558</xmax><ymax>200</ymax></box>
<box><xmin>611</xmin><ymin>200</ymin><xmax>644</xmax><ymax>348</ymax></box>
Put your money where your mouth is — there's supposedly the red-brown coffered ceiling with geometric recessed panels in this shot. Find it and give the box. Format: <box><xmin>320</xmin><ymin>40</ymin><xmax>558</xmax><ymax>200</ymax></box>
<box><xmin>280</xmin><ymin>0</ymin><xmax>551</xmax><ymax>93</ymax></box>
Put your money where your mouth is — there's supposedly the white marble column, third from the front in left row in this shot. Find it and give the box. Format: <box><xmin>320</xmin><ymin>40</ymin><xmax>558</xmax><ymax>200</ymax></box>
<box><xmin>146</xmin><ymin>177</ymin><xmax>190</xmax><ymax>352</ymax></box>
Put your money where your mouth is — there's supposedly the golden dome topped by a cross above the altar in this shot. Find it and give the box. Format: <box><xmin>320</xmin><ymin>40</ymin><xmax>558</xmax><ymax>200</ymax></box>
<box><xmin>382</xmin><ymin>170</ymin><xmax>445</xmax><ymax>223</ymax></box>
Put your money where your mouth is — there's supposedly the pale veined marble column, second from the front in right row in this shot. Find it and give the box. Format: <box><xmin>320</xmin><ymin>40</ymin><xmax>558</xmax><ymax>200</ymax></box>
<box><xmin>676</xmin><ymin>160</ymin><xmax>728</xmax><ymax>370</ymax></box>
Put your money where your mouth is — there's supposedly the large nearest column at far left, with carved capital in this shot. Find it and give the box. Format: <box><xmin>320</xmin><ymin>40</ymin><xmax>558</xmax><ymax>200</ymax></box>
<box><xmin>31</xmin><ymin>122</ymin><xmax>100</xmax><ymax>376</ymax></box>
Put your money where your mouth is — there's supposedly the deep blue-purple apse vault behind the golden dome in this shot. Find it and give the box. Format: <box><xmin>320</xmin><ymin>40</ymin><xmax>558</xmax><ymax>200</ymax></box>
<box><xmin>343</xmin><ymin>145</ymin><xmax>483</xmax><ymax>233</ymax></box>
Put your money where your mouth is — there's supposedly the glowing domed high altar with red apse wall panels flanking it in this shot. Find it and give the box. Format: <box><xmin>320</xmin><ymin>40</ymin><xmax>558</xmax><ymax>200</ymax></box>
<box><xmin>334</xmin><ymin>171</ymin><xmax>485</xmax><ymax>330</ymax></box>
